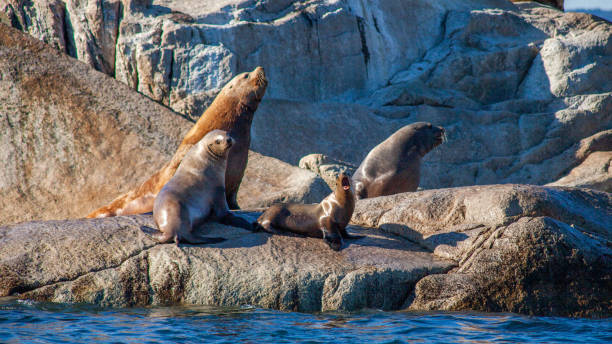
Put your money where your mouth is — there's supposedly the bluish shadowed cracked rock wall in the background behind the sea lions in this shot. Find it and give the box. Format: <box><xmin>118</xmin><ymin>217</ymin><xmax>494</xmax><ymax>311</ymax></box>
<box><xmin>0</xmin><ymin>0</ymin><xmax>612</xmax><ymax>192</ymax></box>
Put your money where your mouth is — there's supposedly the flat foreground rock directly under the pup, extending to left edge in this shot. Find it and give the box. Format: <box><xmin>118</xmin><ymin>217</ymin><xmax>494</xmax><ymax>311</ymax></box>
<box><xmin>0</xmin><ymin>215</ymin><xmax>453</xmax><ymax>312</ymax></box>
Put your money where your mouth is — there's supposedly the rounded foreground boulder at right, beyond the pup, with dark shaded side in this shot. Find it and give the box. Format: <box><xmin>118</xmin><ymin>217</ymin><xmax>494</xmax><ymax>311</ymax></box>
<box><xmin>353</xmin><ymin>185</ymin><xmax>612</xmax><ymax>316</ymax></box>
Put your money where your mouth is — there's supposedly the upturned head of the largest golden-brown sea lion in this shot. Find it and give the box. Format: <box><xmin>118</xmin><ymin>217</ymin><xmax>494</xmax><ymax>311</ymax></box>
<box><xmin>221</xmin><ymin>67</ymin><xmax>268</xmax><ymax>112</ymax></box>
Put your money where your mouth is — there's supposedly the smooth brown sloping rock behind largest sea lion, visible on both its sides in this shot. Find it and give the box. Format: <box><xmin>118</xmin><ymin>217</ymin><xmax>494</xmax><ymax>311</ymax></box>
<box><xmin>0</xmin><ymin>24</ymin><xmax>330</xmax><ymax>224</ymax></box>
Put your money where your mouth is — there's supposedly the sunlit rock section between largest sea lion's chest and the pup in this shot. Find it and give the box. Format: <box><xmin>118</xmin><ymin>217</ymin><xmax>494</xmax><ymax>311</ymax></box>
<box><xmin>238</xmin><ymin>152</ymin><xmax>331</xmax><ymax>209</ymax></box>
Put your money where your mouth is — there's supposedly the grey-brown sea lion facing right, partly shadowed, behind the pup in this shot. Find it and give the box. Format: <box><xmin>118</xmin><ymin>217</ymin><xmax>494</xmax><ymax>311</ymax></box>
<box><xmin>353</xmin><ymin>122</ymin><xmax>446</xmax><ymax>199</ymax></box>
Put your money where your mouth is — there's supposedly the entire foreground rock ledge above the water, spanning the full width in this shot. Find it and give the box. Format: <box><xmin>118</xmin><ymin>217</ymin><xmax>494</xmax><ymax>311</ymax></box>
<box><xmin>0</xmin><ymin>185</ymin><xmax>612</xmax><ymax>317</ymax></box>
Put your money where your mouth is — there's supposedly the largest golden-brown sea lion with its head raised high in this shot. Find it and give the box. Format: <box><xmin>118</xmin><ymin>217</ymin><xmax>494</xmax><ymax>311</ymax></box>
<box><xmin>87</xmin><ymin>67</ymin><xmax>268</xmax><ymax>218</ymax></box>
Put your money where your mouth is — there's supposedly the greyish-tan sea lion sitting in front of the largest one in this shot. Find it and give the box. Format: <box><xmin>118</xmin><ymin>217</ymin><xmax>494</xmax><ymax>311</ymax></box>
<box><xmin>153</xmin><ymin>130</ymin><xmax>253</xmax><ymax>245</ymax></box>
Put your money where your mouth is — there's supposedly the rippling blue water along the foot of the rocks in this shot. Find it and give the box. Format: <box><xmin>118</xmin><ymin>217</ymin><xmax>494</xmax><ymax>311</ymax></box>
<box><xmin>0</xmin><ymin>299</ymin><xmax>612</xmax><ymax>343</ymax></box>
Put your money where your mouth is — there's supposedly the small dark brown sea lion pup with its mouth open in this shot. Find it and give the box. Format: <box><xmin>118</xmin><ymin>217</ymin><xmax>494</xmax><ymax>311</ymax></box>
<box><xmin>253</xmin><ymin>173</ymin><xmax>361</xmax><ymax>251</ymax></box>
